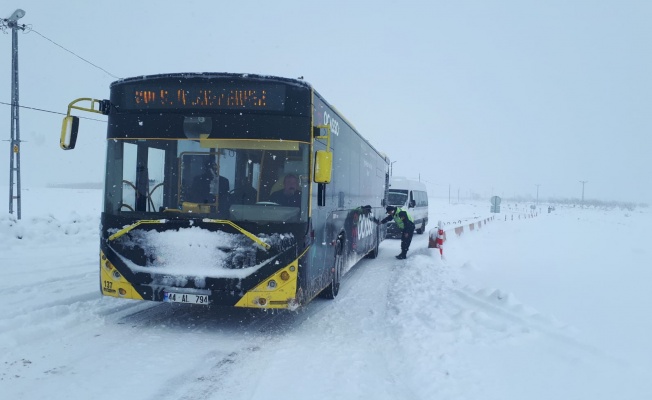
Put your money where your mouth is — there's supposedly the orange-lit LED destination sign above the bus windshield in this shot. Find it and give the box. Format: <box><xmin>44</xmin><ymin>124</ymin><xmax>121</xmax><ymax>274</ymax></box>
<box><xmin>123</xmin><ymin>82</ymin><xmax>285</xmax><ymax>111</ymax></box>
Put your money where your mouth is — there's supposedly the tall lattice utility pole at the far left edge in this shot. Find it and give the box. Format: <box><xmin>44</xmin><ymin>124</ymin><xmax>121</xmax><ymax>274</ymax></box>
<box><xmin>0</xmin><ymin>8</ymin><xmax>25</xmax><ymax>219</ymax></box>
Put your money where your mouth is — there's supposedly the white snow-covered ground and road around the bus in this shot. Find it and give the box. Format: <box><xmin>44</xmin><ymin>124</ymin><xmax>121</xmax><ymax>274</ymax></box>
<box><xmin>0</xmin><ymin>188</ymin><xmax>652</xmax><ymax>400</ymax></box>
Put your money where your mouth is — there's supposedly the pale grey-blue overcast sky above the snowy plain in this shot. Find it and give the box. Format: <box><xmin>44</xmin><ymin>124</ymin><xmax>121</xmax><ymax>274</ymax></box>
<box><xmin>0</xmin><ymin>0</ymin><xmax>652</xmax><ymax>202</ymax></box>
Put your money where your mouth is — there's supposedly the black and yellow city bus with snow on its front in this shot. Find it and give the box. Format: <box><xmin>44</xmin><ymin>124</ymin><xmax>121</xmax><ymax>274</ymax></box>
<box><xmin>60</xmin><ymin>73</ymin><xmax>390</xmax><ymax>309</ymax></box>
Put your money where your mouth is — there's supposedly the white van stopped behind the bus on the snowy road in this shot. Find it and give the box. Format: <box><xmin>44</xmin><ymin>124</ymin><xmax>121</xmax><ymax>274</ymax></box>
<box><xmin>387</xmin><ymin>176</ymin><xmax>428</xmax><ymax>237</ymax></box>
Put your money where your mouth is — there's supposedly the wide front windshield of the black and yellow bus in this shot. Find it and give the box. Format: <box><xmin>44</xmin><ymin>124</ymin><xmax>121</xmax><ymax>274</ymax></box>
<box><xmin>104</xmin><ymin>135</ymin><xmax>310</xmax><ymax>223</ymax></box>
